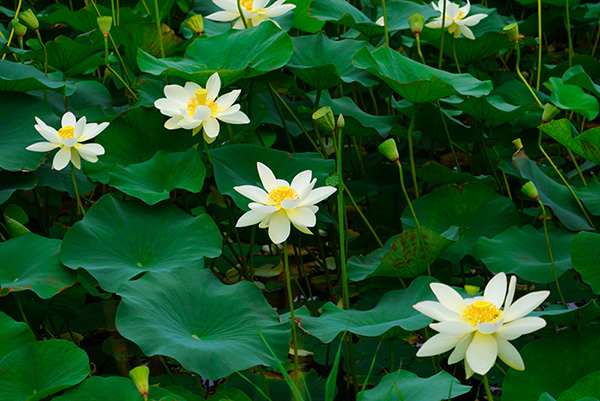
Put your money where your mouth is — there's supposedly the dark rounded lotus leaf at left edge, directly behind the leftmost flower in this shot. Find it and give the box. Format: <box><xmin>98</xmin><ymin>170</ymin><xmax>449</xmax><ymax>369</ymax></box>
<box><xmin>0</xmin><ymin>91</ymin><xmax>59</xmax><ymax>171</ymax></box>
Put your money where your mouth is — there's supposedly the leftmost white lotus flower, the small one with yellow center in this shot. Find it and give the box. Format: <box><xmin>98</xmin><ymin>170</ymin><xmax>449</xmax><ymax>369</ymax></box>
<box><xmin>26</xmin><ymin>112</ymin><xmax>108</xmax><ymax>170</ymax></box>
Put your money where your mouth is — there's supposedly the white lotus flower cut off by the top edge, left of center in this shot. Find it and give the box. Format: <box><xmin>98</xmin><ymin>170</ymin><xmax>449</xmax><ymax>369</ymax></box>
<box><xmin>206</xmin><ymin>0</ymin><xmax>296</xmax><ymax>29</ymax></box>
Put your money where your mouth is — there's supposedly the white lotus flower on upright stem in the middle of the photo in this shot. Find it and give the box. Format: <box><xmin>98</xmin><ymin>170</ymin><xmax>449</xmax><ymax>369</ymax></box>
<box><xmin>233</xmin><ymin>162</ymin><xmax>336</xmax><ymax>244</ymax></box>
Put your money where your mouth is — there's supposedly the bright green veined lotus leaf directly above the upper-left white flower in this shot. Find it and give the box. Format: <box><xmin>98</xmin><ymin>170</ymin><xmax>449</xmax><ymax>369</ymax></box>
<box><xmin>137</xmin><ymin>22</ymin><xmax>294</xmax><ymax>85</ymax></box>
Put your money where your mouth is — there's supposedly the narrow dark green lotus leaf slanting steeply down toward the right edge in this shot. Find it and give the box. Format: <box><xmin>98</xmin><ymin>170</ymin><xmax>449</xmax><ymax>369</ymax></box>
<box><xmin>512</xmin><ymin>150</ymin><xmax>592</xmax><ymax>230</ymax></box>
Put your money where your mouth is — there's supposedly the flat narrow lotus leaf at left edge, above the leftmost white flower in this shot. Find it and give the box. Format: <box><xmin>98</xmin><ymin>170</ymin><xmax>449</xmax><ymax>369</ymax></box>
<box><xmin>0</xmin><ymin>60</ymin><xmax>75</xmax><ymax>94</ymax></box>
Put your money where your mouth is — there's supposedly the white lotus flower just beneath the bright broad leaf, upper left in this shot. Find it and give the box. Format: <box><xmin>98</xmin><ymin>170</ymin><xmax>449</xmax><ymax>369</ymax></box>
<box><xmin>154</xmin><ymin>72</ymin><xmax>250</xmax><ymax>143</ymax></box>
